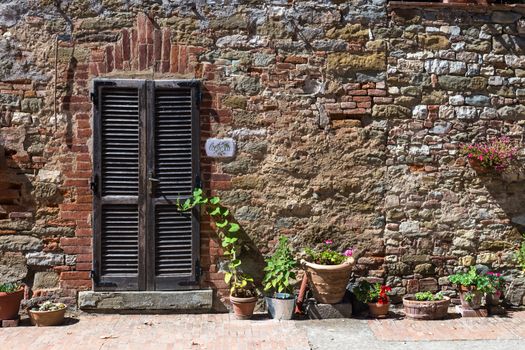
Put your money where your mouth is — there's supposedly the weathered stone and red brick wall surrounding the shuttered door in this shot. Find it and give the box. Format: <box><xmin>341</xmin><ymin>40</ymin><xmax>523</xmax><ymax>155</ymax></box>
<box><xmin>0</xmin><ymin>0</ymin><xmax>525</xmax><ymax>308</ymax></box>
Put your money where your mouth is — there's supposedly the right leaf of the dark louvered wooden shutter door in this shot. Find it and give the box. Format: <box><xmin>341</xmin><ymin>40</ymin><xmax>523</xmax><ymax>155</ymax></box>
<box><xmin>148</xmin><ymin>81</ymin><xmax>199</xmax><ymax>290</ymax></box>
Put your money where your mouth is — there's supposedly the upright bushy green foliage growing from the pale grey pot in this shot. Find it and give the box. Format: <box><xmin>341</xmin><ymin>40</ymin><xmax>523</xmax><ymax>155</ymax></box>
<box><xmin>263</xmin><ymin>236</ymin><xmax>297</xmax><ymax>294</ymax></box>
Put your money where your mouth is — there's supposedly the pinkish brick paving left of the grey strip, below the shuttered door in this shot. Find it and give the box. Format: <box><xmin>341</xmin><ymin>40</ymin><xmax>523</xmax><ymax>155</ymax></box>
<box><xmin>0</xmin><ymin>314</ymin><xmax>310</xmax><ymax>350</ymax></box>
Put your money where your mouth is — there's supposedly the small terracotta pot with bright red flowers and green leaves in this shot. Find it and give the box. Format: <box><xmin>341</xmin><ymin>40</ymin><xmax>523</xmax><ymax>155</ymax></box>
<box><xmin>352</xmin><ymin>280</ymin><xmax>392</xmax><ymax>318</ymax></box>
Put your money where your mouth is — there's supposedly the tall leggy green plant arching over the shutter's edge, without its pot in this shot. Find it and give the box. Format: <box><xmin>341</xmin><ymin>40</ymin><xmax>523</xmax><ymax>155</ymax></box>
<box><xmin>176</xmin><ymin>188</ymin><xmax>256</xmax><ymax>298</ymax></box>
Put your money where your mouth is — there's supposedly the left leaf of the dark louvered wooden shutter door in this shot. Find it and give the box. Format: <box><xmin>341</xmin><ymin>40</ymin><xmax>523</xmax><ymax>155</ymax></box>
<box><xmin>93</xmin><ymin>81</ymin><xmax>144</xmax><ymax>290</ymax></box>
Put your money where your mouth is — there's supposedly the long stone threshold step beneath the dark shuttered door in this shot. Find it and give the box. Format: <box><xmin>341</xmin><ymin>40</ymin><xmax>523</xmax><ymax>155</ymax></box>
<box><xmin>78</xmin><ymin>289</ymin><xmax>213</xmax><ymax>313</ymax></box>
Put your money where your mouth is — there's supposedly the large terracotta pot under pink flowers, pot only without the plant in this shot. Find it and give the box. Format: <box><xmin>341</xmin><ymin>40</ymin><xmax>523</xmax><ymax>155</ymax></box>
<box><xmin>301</xmin><ymin>258</ymin><xmax>354</xmax><ymax>304</ymax></box>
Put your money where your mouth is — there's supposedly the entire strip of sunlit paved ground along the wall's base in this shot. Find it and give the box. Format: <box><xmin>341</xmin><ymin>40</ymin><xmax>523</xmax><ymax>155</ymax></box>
<box><xmin>0</xmin><ymin>311</ymin><xmax>525</xmax><ymax>350</ymax></box>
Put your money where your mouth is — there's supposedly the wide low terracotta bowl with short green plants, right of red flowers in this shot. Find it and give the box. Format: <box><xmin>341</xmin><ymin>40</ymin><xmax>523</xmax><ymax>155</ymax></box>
<box><xmin>403</xmin><ymin>292</ymin><xmax>450</xmax><ymax>320</ymax></box>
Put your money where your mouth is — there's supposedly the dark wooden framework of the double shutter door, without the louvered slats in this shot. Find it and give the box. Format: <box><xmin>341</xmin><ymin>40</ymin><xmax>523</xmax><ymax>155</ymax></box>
<box><xmin>90</xmin><ymin>78</ymin><xmax>201</xmax><ymax>291</ymax></box>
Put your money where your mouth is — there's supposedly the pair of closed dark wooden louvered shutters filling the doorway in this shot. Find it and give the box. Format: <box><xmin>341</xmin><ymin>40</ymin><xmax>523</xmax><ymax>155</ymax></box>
<box><xmin>93</xmin><ymin>79</ymin><xmax>199</xmax><ymax>290</ymax></box>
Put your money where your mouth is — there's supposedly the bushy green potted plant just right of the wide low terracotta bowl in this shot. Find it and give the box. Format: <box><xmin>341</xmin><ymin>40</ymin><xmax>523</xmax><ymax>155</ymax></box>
<box><xmin>448</xmin><ymin>266</ymin><xmax>493</xmax><ymax>310</ymax></box>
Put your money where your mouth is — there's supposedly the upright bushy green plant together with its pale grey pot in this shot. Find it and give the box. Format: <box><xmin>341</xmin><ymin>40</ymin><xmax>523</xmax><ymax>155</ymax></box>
<box><xmin>263</xmin><ymin>236</ymin><xmax>297</xmax><ymax>320</ymax></box>
